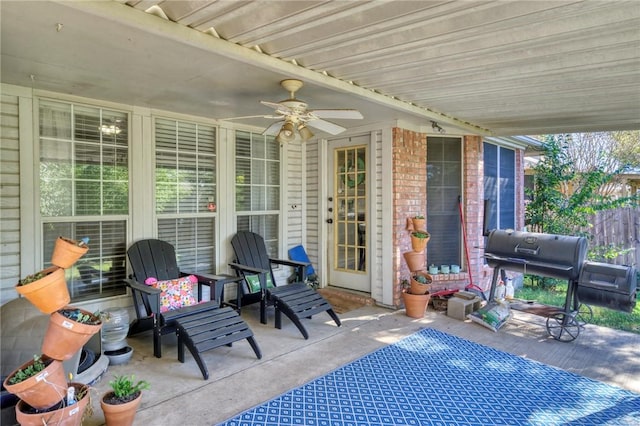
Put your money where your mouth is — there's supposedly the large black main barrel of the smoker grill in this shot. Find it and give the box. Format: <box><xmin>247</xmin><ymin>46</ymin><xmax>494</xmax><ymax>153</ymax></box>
<box><xmin>485</xmin><ymin>229</ymin><xmax>587</xmax><ymax>280</ymax></box>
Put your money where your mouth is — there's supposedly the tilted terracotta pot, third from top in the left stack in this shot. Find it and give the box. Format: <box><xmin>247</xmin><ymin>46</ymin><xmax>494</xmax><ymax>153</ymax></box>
<box><xmin>42</xmin><ymin>307</ymin><xmax>102</xmax><ymax>361</ymax></box>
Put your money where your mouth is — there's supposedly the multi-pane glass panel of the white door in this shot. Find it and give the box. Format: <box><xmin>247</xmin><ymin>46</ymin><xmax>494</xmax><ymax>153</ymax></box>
<box><xmin>334</xmin><ymin>146</ymin><xmax>367</xmax><ymax>272</ymax></box>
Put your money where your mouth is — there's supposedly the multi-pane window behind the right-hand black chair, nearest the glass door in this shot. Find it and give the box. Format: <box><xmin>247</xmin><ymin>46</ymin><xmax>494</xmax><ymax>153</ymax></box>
<box><xmin>236</xmin><ymin>131</ymin><xmax>280</xmax><ymax>256</ymax></box>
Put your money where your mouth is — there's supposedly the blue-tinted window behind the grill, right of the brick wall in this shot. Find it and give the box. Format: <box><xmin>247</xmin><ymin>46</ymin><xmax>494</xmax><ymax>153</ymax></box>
<box><xmin>484</xmin><ymin>142</ymin><xmax>516</xmax><ymax>230</ymax></box>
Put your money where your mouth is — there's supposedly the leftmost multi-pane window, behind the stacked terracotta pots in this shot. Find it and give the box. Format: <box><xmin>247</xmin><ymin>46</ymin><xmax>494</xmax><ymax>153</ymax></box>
<box><xmin>39</xmin><ymin>100</ymin><xmax>129</xmax><ymax>301</ymax></box>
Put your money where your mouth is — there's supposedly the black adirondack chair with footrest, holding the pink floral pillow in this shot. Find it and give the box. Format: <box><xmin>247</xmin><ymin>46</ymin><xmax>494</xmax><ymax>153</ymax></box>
<box><xmin>126</xmin><ymin>239</ymin><xmax>262</xmax><ymax>380</ymax></box>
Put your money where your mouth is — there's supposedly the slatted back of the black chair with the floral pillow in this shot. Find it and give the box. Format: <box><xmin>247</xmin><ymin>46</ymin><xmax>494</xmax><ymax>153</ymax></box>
<box><xmin>127</xmin><ymin>239</ymin><xmax>180</xmax><ymax>283</ymax></box>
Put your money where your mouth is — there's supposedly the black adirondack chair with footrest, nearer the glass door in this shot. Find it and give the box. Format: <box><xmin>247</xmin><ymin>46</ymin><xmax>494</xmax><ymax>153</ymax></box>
<box><xmin>229</xmin><ymin>231</ymin><xmax>341</xmax><ymax>339</ymax></box>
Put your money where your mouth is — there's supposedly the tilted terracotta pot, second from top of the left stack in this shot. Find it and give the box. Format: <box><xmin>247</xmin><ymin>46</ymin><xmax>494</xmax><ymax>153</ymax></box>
<box><xmin>16</xmin><ymin>266</ymin><xmax>71</xmax><ymax>314</ymax></box>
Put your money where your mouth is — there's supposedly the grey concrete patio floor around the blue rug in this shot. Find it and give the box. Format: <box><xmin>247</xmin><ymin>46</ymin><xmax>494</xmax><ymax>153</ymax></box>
<box><xmin>83</xmin><ymin>305</ymin><xmax>640</xmax><ymax>426</ymax></box>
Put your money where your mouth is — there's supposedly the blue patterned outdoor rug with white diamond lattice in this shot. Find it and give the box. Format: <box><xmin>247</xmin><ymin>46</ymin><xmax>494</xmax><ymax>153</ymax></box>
<box><xmin>216</xmin><ymin>329</ymin><xmax>640</xmax><ymax>426</ymax></box>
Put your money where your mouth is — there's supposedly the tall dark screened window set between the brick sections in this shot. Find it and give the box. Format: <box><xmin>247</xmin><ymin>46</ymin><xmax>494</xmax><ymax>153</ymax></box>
<box><xmin>427</xmin><ymin>136</ymin><xmax>462</xmax><ymax>265</ymax></box>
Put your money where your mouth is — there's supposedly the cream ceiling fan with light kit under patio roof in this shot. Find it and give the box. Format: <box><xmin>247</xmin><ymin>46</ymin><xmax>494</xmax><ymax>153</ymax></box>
<box><xmin>229</xmin><ymin>79</ymin><xmax>363</xmax><ymax>142</ymax></box>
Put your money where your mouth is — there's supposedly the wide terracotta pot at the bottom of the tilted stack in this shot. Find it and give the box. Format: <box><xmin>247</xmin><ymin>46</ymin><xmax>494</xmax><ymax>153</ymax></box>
<box><xmin>16</xmin><ymin>383</ymin><xmax>90</xmax><ymax>426</ymax></box>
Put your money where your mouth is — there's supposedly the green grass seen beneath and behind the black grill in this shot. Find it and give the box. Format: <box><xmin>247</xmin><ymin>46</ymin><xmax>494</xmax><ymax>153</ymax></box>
<box><xmin>515</xmin><ymin>283</ymin><xmax>640</xmax><ymax>334</ymax></box>
